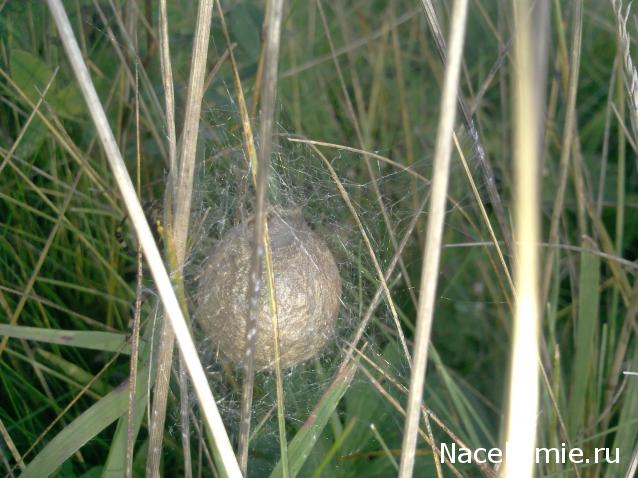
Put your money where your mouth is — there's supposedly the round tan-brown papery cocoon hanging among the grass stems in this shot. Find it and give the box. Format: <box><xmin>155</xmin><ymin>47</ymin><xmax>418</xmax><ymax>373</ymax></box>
<box><xmin>196</xmin><ymin>210</ymin><xmax>341</xmax><ymax>368</ymax></box>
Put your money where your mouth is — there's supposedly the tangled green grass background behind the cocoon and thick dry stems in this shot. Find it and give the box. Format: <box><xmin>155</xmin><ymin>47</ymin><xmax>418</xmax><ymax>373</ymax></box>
<box><xmin>0</xmin><ymin>0</ymin><xmax>638</xmax><ymax>477</ymax></box>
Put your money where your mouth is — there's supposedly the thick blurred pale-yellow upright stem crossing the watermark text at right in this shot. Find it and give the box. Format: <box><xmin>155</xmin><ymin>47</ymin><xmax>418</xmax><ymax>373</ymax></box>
<box><xmin>503</xmin><ymin>1</ymin><xmax>548</xmax><ymax>472</ymax></box>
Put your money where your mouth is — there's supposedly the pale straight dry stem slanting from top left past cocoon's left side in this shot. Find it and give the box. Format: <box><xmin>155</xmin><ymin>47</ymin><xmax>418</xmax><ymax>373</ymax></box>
<box><xmin>47</xmin><ymin>0</ymin><xmax>241</xmax><ymax>477</ymax></box>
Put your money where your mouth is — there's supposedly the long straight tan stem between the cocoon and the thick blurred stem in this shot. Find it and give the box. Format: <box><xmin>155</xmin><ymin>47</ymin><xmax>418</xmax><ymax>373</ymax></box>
<box><xmin>399</xmin><ymin>0</ymin><xmax>467</xmax><ymax>478</ymax></box>
